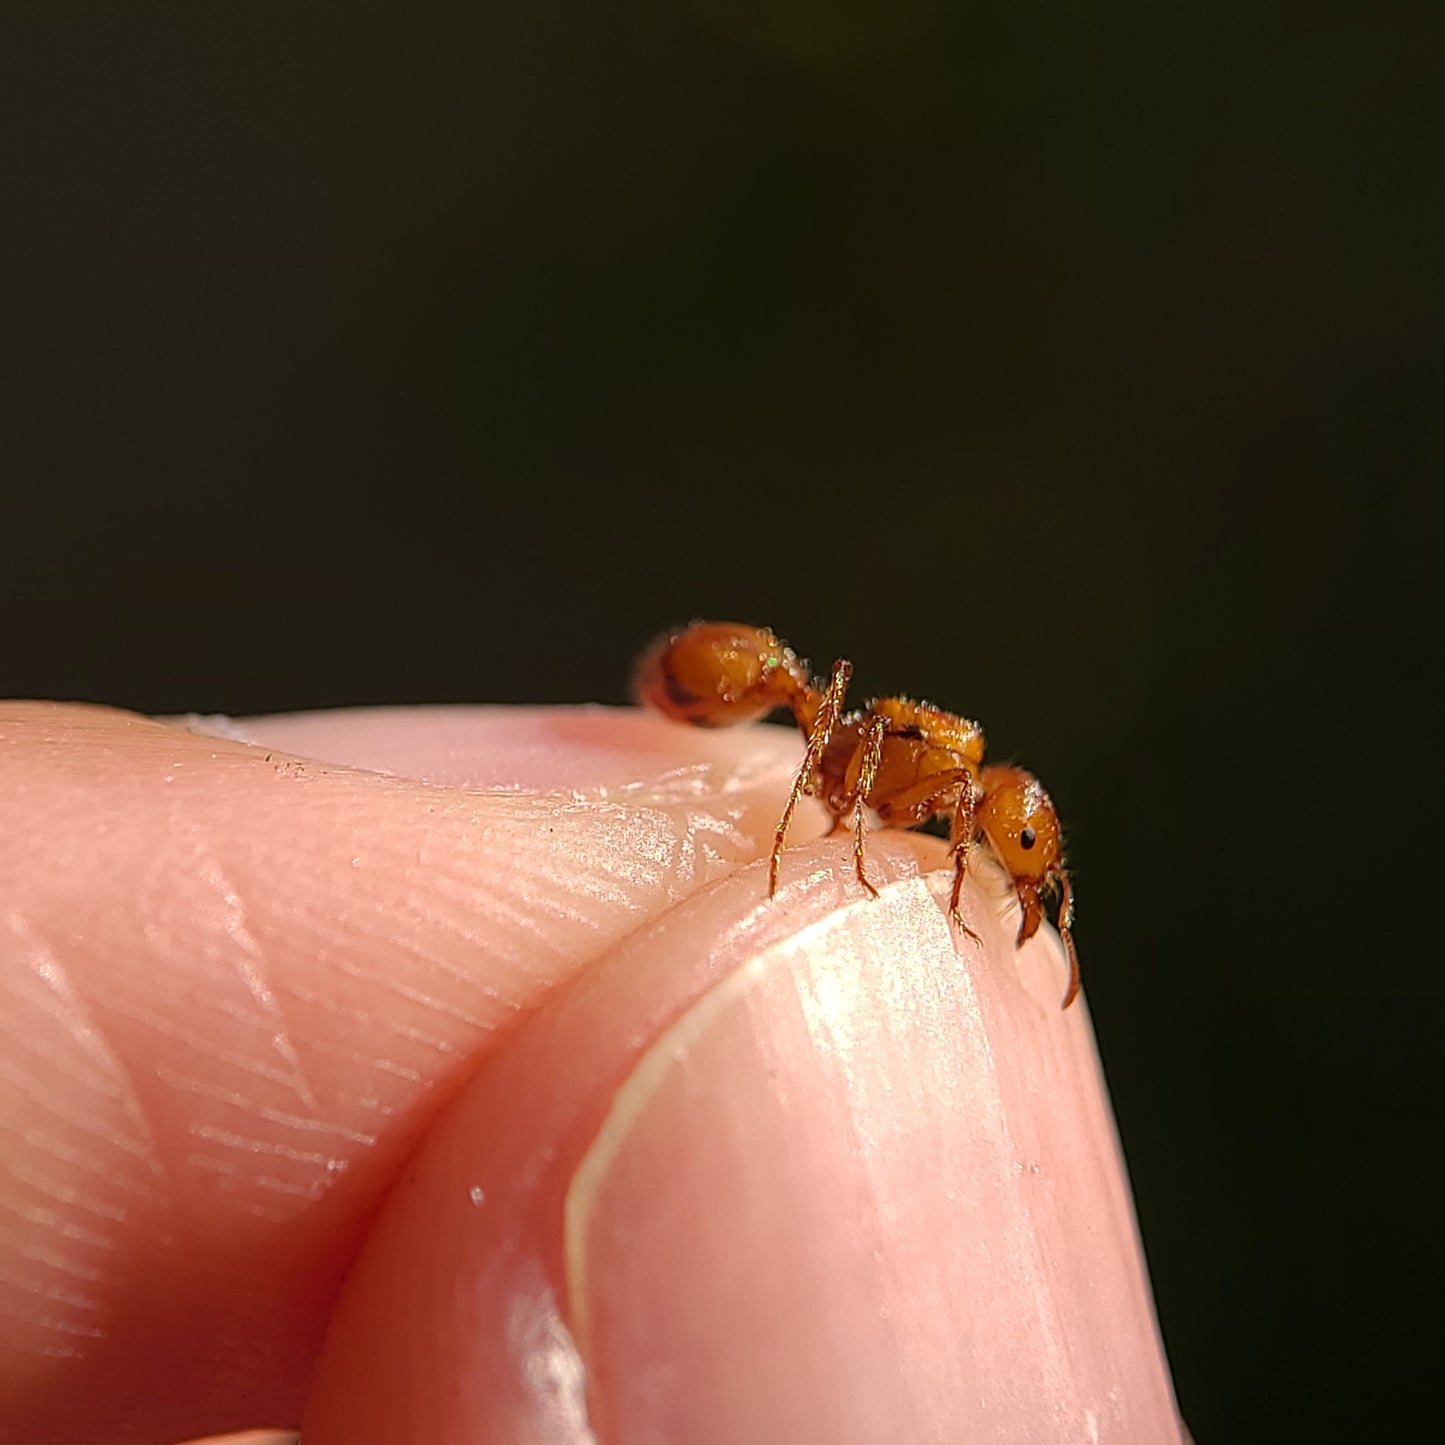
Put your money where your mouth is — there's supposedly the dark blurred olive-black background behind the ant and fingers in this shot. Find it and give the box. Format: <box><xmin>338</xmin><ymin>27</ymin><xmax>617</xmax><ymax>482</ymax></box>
<box><xmin>0</xmin><ymin>0</ymin><xmax>1445</xmax><ymax>1445</ymax></box>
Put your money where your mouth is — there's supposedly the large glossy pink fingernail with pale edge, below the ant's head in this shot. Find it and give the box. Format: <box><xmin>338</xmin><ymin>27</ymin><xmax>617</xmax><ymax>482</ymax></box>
<box><xmin>565</xmin><ymin>886</ymin><xmax>1179</xmax><ymax>1445</ymax></box>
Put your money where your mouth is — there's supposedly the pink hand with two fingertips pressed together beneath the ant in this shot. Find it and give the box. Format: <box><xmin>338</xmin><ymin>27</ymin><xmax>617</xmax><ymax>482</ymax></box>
<box><xmin>0</xmin><ymin>704</ymin><xmax>1181</xmax><ymax>1445</ymax></box>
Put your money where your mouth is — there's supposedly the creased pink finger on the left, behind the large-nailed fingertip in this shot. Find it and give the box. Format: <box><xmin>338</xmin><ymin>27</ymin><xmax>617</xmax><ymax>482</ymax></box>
<box><xmin>0</xmin><ymin>704</ymin><xmax>798</xmax><ymax>1445</ymax></box>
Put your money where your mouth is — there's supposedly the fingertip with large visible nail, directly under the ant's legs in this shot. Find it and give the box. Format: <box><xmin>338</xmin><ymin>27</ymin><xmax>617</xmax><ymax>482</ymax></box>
<box><xmin>306</xmin><ymin>838</ymin><xmax>1178</xmax><ymax>1445</ymax></box>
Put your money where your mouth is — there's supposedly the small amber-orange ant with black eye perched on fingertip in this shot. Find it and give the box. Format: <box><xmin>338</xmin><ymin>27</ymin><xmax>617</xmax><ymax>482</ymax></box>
<box><xmin>634</xmin><ymin>623</ymin><xmax>1079</xmax><ymax>1009</ymax></box>
